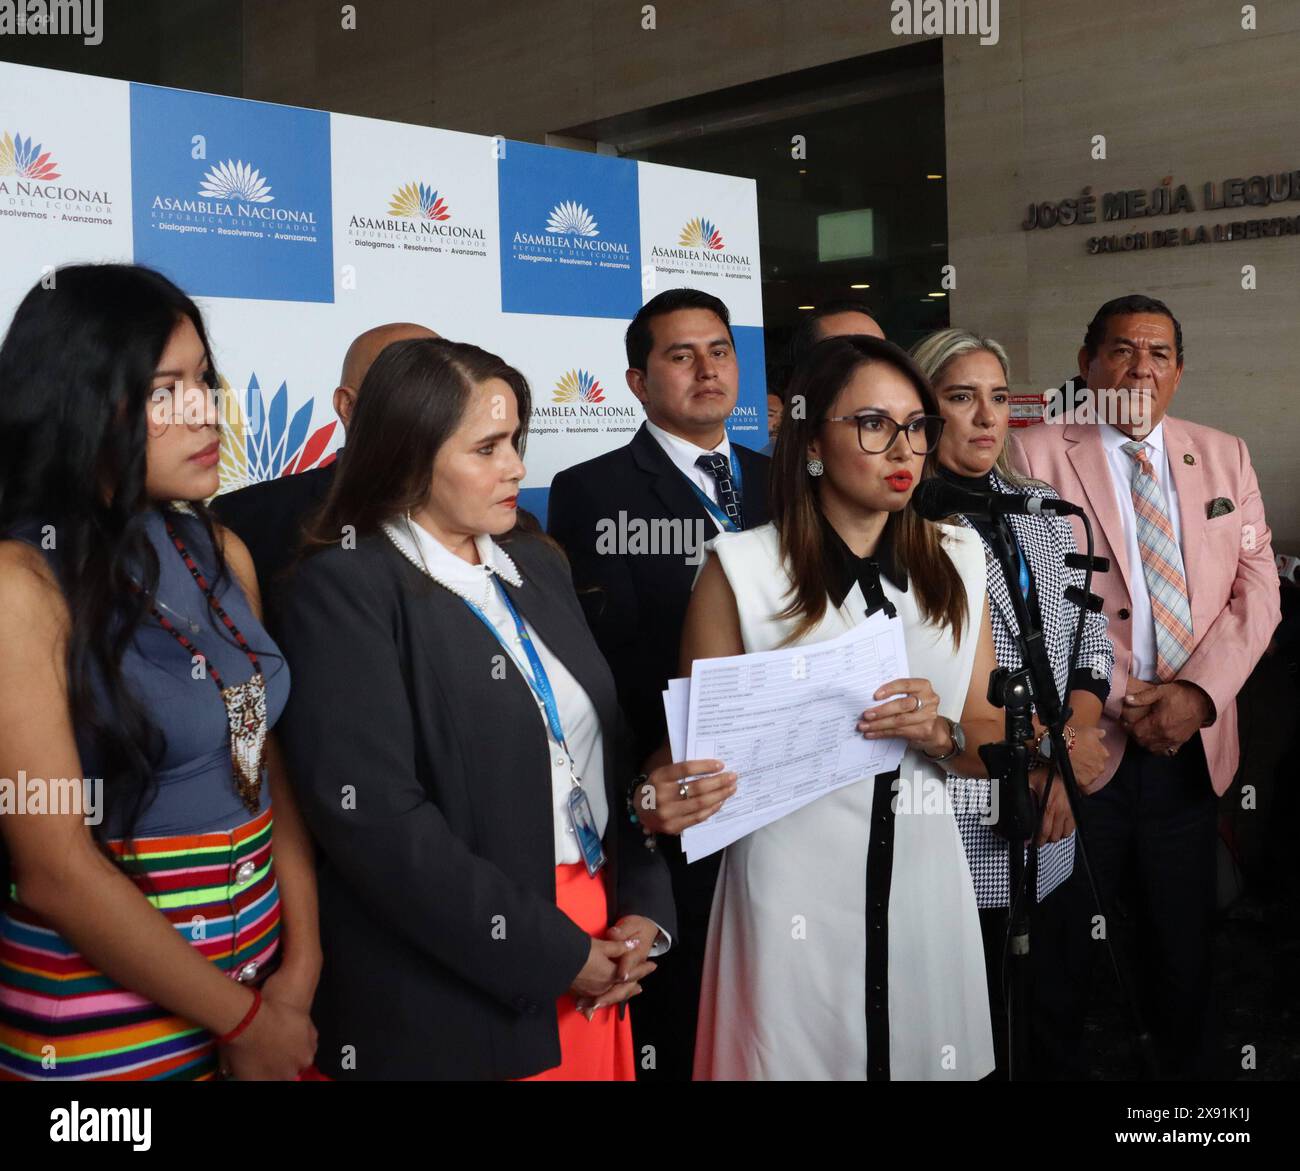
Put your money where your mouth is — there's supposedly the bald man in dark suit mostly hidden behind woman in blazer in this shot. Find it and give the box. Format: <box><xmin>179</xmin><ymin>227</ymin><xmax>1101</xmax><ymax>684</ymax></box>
<box><xmin>212</xmin><ymin>321</ymin><xmax>438</xmax><ymax>620</ymax></box>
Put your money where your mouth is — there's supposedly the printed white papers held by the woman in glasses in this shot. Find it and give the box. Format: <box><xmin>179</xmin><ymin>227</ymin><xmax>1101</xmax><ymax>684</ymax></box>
<box><xmin>670</xmin><ymin>612</ymin><xmax>909</xmax><ymax>862</ymax></box>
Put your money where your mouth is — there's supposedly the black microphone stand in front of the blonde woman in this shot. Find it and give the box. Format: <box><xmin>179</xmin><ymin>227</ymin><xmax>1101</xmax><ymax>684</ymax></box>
<box><xmin>979</xmin><ymin>512</ymin><xmax>1154</xmax><ymax>1081</ymax></box>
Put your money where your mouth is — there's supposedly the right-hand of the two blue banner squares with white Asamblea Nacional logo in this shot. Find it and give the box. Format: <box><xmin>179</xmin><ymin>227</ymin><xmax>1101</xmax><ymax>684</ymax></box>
<box><xmin>498</xmin><ymin>142</ymin><xmax>641</xmax><ymax>318</ymax></box>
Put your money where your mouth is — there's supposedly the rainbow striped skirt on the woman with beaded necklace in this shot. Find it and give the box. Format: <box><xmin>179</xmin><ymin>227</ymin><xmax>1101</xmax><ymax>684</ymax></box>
<box><xmin>0</xmin><ymin>808</ymin><xmax>280</xmax><ymax>1081</ymax></box>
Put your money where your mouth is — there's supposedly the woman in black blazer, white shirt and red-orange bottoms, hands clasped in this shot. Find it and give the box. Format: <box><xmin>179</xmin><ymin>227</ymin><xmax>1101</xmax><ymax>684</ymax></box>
<box><xmin>281</xmin><ymin>339</ymin><xmax>696</xmax><ymax>1080</ymax></box>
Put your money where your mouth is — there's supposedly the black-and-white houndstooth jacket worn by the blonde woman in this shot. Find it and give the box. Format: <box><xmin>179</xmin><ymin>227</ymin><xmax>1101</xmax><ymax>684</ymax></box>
<box><xmin>949</xmin><ymin>472</ymin><xmax>1115</xmax><ymax>908</ymax></box>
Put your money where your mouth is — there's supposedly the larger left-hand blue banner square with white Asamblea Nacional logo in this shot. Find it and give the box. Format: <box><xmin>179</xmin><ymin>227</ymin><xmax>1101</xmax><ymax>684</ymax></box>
<box><xmin>131</xmin><ymin>84</ymin><xmax>334</xmax><ymax>302</ymax></box>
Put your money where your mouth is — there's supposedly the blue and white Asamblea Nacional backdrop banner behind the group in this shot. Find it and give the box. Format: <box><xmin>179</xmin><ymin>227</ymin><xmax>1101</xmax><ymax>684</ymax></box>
<box><xmin>0</xmin><ymin>64</ymin><xmax>767</xmax><ymax>519</ymax></box>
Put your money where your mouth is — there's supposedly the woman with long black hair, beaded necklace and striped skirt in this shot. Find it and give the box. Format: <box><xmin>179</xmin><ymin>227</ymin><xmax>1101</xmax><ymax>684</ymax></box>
<box><xmin>0</xmin><ymin>265</ymin><xmax>320</xmax><ymax>1080</ymax></box>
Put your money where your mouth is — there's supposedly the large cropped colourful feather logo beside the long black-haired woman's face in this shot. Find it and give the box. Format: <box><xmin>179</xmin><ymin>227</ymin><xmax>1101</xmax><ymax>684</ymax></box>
<box><xmin>221</xmin><ymin>374</ymin><xmax>338</xmax><ymax>493</ymax></box>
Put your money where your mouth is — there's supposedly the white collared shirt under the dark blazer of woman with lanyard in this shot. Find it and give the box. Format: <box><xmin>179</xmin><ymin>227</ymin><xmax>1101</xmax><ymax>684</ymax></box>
<box><xmin>385</xmin><ymin>517</ymin><xmax>610</xmax><ymax>866</ymax></box>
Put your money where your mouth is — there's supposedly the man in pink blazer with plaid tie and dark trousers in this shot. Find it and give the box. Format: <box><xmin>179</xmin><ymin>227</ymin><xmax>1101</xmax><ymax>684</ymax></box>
<box><xmin>1015</xmin><ymin>295</ymin><xmax>1281</xmax><ymax>1076</ymax></box>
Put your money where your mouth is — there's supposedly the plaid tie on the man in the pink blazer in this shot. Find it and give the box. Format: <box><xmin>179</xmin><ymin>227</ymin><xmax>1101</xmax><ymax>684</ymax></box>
<box><xmin>1122</xmin><ymin>442</ymin><xmax>1196</xmax><ymax>682</ymax></box>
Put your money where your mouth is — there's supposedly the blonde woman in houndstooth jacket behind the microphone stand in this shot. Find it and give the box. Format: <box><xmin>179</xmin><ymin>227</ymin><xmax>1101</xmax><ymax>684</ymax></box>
<box><xmin>913</xmin><ymin>329</ymin><xmax>1114</xmax><ymax>1076</ymax></box>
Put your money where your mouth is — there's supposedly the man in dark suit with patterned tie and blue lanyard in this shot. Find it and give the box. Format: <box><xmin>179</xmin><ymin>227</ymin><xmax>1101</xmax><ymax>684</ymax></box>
<box><xmin>549</xmin><ymin>289</ymin><xmax>770</xmax><ymax>1080</ymax></box>
